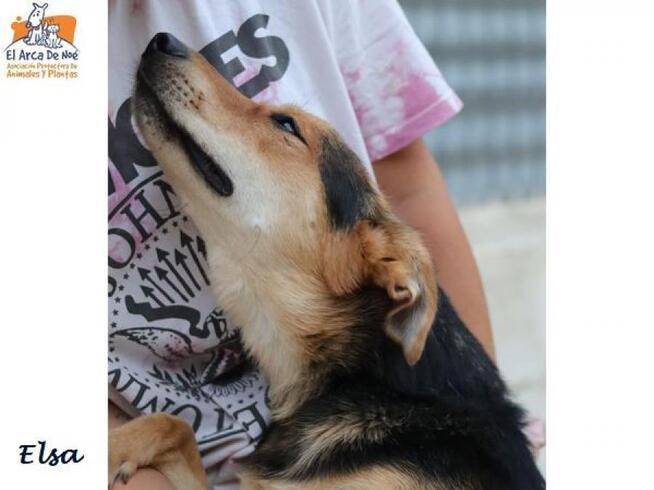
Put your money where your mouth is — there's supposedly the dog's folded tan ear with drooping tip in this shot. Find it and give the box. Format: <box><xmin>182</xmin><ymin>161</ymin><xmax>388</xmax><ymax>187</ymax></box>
<box><xmin>325</xmin><ymin>219</ymin><xmax>437</xmax><ymax>365</ymax></box>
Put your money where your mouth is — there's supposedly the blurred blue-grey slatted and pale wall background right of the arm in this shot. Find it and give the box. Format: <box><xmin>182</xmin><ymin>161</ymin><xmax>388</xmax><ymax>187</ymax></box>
<box><xmin>400</xmin><ymin>0</ymin><xmax>545</xmax><ymax>470</ymax></box>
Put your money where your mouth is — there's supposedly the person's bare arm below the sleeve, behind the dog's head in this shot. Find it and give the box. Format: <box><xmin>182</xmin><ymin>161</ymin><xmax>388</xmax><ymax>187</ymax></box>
<box><xmin>373</xmin><ymin>139</ymin><xmax>495</xmax><ymax>360</ymax></box>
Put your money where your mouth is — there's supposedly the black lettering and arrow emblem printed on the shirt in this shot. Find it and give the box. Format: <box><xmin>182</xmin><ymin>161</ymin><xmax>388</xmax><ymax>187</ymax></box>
<box><xmin>108</xmin><ymin>14</ymin><xmax>290</xmax><ymax>445</ymax></box>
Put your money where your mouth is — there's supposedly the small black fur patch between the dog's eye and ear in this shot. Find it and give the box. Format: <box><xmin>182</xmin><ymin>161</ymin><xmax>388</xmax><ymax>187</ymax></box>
<box><xmin>320</xmin><ymin>134</ymin><xmax>375</xmax><ymax>229</ymax></box>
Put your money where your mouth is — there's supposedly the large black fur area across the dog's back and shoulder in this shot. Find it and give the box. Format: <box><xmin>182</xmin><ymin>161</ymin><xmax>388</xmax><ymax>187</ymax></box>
<box><xmin>247</xmin><ymin>291</ymin><xmax>545</xmax><ymax>490</ymax></box>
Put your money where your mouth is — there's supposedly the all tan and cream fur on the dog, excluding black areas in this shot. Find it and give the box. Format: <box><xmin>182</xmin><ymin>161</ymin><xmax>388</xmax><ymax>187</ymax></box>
<box><xmin>109</xmin><ymin>36</ymin><xmax>440</xmax><ymax>490</ymax></box>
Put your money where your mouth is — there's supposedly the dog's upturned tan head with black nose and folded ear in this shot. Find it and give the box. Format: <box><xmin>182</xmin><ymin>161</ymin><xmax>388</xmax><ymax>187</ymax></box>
<box><xmin>133</xmin><ymin>34</ymin><xmax>436</xmax><ymax>364</ymax></box>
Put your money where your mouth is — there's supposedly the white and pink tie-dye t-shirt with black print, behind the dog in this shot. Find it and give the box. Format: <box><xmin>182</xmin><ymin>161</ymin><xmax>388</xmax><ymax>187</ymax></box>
<box><xmin>108</xmin><ymin>0</ymin><xmax>461</xmax><ymax>489</ymax></box>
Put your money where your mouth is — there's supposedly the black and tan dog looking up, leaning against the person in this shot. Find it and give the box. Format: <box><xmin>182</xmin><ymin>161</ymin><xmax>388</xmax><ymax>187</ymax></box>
<box><xmin>109</xmin><ymin>33</ymin><xmax>545</xmax><ymax>490</ymax></box>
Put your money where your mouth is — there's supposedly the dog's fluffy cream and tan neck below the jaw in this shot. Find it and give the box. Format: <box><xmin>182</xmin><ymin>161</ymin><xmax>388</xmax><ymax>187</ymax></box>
<box><xmin>208</xmin><ymin>241</ymin><xmax>356</xmax><ymax>419</ymax></box>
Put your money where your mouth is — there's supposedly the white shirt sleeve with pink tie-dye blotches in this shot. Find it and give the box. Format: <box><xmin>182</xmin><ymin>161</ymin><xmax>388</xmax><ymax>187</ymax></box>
<box><xmin>321</xmin><ymin>0</ymin><xmax>463</xmax><ymax>161</ymax></box>
